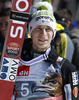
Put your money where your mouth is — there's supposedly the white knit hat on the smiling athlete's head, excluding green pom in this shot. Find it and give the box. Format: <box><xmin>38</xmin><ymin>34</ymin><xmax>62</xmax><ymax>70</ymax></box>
<box><xmin>29</xmin><ymin>10</ymin><xmax>56</xmax><ymax>37</ymax></box>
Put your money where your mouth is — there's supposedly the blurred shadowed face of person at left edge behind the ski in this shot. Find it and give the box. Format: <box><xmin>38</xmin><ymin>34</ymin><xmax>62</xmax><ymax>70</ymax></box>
<box><xmin>0</xmin><ymin>16</ymin><xmax>9</xmax><ymax>38</ymax></box>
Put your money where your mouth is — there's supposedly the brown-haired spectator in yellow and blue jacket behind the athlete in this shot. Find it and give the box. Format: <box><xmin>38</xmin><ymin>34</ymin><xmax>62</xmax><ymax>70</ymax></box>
<box><xmin>53</xmin><ymin>9</ymin><xmax>74</xmax><ymax>62</ymax></box>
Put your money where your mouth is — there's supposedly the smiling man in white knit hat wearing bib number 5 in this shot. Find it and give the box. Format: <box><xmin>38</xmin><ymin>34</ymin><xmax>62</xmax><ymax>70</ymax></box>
<box><xmin>14</xmin><ymin>10</ymin><xmax>78</xmax><ymax>100</ymax></box>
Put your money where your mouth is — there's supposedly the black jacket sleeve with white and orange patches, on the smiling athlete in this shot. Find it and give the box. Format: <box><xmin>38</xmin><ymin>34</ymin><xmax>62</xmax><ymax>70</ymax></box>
<box><xmin>61</xmin><ymin>59</ymin><xmax>79</xmax><ymax>100</ymax></box>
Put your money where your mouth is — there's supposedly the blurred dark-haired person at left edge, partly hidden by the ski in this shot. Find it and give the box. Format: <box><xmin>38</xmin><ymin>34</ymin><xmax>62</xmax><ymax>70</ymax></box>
<box><xmin>0</xmin><ymin>8</ymin><xmax>10</xmax><ymax>59</ymax></box>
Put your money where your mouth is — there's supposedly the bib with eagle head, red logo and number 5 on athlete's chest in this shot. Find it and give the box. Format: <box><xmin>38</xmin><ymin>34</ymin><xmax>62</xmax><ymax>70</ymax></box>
<box><xmin>15</xmin><ymin>61</ymin><xmax>62</xmax><ymax>100</ymax></box>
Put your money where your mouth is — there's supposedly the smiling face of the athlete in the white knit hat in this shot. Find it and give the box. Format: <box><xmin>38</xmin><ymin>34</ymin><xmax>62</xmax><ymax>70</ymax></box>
<box><xmin>31</xmin><ymin>25</ymin><xmax>54</xmax><ymax>51</ymax></box>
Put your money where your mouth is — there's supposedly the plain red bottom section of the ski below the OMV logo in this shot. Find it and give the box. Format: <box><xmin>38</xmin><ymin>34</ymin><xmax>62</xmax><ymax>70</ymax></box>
<box><xmin>0</xmin><ymin>80</ymin><xmax>14</xmax><ymax>100</ymax></box>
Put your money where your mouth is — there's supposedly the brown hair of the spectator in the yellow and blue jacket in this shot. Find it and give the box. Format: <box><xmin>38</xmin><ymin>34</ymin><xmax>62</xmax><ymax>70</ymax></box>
<box><xmin>54</xmin><ymin>9</ymin><xmax>73</xmax><ymax>22</ymax></box>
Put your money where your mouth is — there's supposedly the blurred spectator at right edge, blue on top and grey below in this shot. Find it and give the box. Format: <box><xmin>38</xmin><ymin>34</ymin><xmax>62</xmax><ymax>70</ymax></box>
<box><xmin>70</xmin><ymin>22</ymin><xmax>79</xmax><ymax>70</ymax></box>
